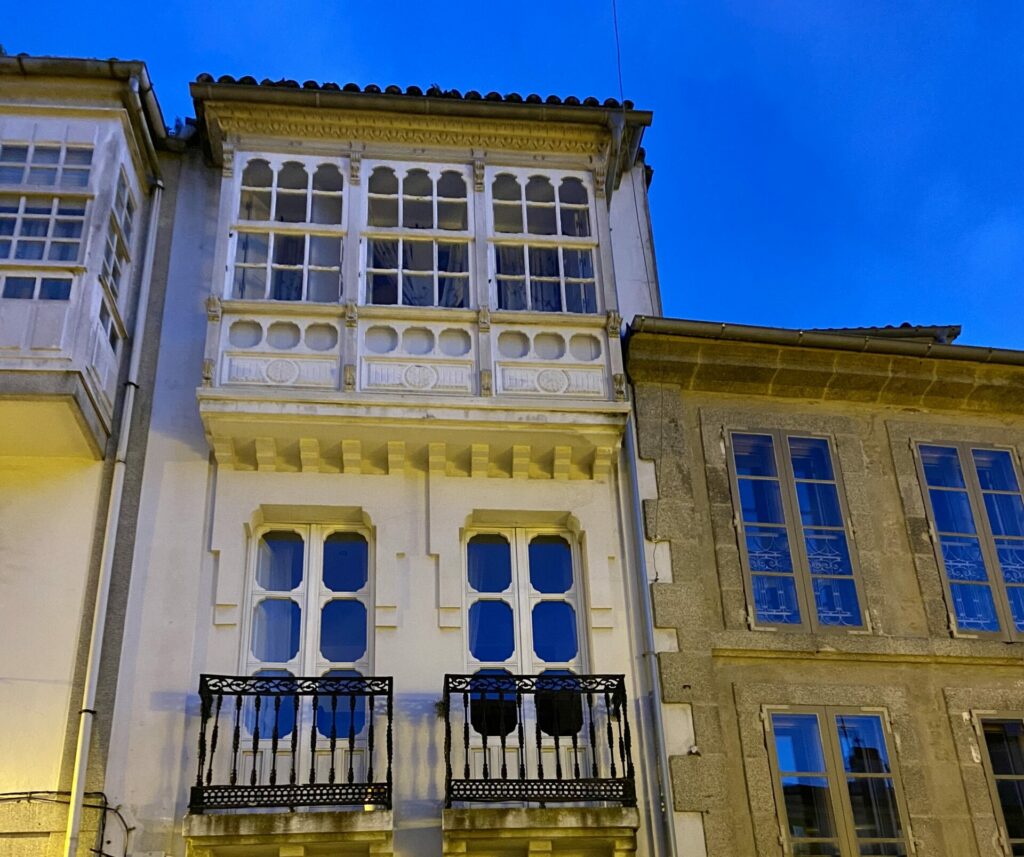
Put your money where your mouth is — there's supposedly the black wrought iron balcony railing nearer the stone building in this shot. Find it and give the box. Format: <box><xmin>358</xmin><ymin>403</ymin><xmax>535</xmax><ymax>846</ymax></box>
<box><xmin>444</xmin><ymin>671</ymin><xmax>636</xmax><ymax>807</ymax></box>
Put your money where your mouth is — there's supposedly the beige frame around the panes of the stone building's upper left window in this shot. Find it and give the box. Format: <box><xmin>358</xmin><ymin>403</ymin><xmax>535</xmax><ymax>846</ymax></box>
<box><xmin>720</xmin><ymin>421</ymin><xmax>871</xmax><ymax>634</ymax></box>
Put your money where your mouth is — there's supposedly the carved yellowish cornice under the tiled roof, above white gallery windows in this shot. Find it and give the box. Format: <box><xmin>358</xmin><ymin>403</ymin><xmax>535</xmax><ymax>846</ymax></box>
<box><xmin>204</xmin><ymin>101</ymin><xmax>610</xmax><ymax>162</ymax></box>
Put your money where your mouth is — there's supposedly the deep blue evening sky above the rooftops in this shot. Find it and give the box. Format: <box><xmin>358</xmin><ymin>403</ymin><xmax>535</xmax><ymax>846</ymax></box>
<box><xmin>8</xmin><ymin>0</ymin><xmax>1024</xmax><ymax>348</ymax></box>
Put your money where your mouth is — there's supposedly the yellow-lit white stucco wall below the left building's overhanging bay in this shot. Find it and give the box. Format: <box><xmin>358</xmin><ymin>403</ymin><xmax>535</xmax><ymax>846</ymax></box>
<box><xmin>0</xmin><ymin>458</ymin><xmax>101</xmax><ymax>791</ymax></box>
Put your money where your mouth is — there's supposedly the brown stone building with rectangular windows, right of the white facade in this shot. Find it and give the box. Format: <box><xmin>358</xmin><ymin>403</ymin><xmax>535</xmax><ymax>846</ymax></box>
<box><xmin>627</xmin><ymin>318</ymin><xmax>1024</xmax><ymax>857</ymax></box>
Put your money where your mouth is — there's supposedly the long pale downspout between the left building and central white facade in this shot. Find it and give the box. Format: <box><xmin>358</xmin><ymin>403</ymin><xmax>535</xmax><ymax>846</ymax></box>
<box><xmin>63</xmin><ymin>152</ymin><xmax>164</xmax><ymax>857</ymax></box>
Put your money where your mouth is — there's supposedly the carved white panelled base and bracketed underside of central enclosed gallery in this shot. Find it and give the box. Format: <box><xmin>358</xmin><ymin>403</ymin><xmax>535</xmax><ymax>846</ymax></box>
<box><xmin>198</xmin><ymin>299</ymin><xmax>628</xmax><ymax>479</ymax></box>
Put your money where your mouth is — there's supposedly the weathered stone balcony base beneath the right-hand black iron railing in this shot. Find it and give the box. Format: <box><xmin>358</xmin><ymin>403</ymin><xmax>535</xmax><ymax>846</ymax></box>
<box><xmin>441</xmin><ymin>807</ymin><xmax>640</xmax><ymax>857</ymax></box>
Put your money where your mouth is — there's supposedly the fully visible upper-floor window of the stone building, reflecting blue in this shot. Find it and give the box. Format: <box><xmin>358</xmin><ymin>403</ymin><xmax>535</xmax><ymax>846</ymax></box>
<box><xmin>731</xmin><ymin>432</ymin><xmax>863</xmax><ymax>629</ymax></box>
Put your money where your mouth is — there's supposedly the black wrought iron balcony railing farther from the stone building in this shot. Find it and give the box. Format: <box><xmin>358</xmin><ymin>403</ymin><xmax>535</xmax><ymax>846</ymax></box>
<box><xmin>188</xmin><ymin>674</ymin><xmax>393</xmax><ymax>813</ymax></box>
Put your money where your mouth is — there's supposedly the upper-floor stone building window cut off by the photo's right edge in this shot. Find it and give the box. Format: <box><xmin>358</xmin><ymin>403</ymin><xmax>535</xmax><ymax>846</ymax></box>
<box><xmin>918</xmin><ymin>443</ymin><xmax>1024</xmax><ymax>639</ymax></box>
